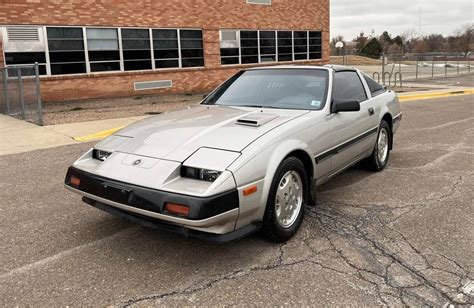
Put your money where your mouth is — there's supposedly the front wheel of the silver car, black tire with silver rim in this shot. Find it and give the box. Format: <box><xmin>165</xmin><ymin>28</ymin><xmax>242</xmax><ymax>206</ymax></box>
<box><xmin>261</xmin><ymin>157</ymin><xmax>309</xmax><ymax>242</ymax></box>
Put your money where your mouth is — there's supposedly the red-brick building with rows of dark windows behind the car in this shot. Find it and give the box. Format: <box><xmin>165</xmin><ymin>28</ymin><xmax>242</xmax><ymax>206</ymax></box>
<box><xmin>0</xmin><ymin>0</ymin><xmax>329</xmax><ymax>101</ymax></box>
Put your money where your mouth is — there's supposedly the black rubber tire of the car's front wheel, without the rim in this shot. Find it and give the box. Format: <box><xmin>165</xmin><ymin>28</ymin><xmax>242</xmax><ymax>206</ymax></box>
<box><xmin>262</xmin><ymin>157</ymin><xmax>308</xmax><ymax>242</ymax></box>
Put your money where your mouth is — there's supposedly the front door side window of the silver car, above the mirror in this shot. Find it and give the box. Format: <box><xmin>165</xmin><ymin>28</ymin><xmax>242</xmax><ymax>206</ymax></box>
<box><xmin>332</xmin><ymin>71</ymin><xmax>367</xmax><ymax>102</ymax></box>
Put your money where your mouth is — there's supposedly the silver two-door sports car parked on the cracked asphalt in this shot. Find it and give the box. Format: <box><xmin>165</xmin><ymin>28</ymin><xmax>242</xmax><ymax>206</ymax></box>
<box><xmin>65</xmin><ymin>66</ymin><xmax>402</xmax><ymax>242</ymax></box>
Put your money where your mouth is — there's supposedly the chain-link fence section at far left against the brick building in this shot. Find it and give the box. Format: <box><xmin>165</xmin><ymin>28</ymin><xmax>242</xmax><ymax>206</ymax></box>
<box><xmin>0</xmin><ymin>64</ymin><xmax>43</xmax><ymax>125</ymax></box>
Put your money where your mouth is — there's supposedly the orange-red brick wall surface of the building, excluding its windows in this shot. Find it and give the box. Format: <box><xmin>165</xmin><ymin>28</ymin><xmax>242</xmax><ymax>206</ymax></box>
<box><xmin>0</xmin><ymin>0</ymin><xmax>329</xmax><ymax>101</ymax></box>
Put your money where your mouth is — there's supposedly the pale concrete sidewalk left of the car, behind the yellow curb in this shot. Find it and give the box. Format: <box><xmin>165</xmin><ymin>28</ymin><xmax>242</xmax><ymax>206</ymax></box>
<box><xmin>0</xmin><ymin>114</ymin><xmax>145</xmax><ymax>155</ymax></box>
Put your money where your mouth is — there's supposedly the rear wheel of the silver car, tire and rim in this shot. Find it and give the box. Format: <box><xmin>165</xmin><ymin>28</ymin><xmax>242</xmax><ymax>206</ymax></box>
<box><xmin>366</xmin><ymin>120</ymin><xmax>392</xmax><ymax>171</ymax></box>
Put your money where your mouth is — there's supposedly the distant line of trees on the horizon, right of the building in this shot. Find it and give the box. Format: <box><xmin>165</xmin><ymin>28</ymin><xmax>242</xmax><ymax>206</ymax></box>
<box><xmin>331</xmin><ymin>23</ymin><xmax>474</xmax><ymax>58</ymax></box>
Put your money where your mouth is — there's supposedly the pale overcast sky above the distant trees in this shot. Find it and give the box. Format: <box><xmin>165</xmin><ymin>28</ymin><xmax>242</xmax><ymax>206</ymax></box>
<box><xmin>330</xmin><ymin>0</ymin><xmax>474</xmax><ymax>40</ymax></box>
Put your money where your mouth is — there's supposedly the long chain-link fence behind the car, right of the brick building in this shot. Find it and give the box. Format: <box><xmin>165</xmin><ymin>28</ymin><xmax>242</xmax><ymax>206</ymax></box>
<box><xmin>331</xmin><ymin>53</ymin><xmax>474</xmax><ymax>87</ymax></box>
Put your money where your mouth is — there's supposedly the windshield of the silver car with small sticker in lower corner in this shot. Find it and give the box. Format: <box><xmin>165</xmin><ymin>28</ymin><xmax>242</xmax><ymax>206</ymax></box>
<box><xmin>203</xmin><ymin>69</ymin><xmax>328</xmax><ymax>110</ymax></box>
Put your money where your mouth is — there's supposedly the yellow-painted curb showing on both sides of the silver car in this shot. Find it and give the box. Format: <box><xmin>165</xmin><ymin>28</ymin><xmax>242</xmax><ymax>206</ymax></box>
<box><xmin>73</xmin><ymin>89</ymin><xmax>474</xmax><ymax>142</ymax></box>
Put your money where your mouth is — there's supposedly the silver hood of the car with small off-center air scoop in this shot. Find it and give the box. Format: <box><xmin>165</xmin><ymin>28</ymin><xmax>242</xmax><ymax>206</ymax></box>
<box><xmin>107</xmin><ymin>105</ymin><xmax>308</xmax><ymax>162</ymax></box>
